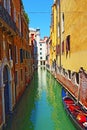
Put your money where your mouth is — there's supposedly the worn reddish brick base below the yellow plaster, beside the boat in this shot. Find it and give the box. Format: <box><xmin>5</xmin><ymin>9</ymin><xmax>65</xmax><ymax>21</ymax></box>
<box><xmin>56</xmin><ymin>67</ymin><xmax>87</xmax><ymax>108</ymax></box>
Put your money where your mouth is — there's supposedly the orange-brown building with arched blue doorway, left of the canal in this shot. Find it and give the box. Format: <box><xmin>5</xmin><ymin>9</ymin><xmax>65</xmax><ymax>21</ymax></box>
<box><xmin>0</xmin><ymin>0</ymin><xmax>33</xmax><ymax>127</ymax></box>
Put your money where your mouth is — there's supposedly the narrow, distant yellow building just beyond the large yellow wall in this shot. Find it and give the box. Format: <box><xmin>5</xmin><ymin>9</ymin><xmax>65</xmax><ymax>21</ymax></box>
<box><xmin>50</xmin><ymin>2</ymin><xmax>57</xmax><ymax>69</ymax></box>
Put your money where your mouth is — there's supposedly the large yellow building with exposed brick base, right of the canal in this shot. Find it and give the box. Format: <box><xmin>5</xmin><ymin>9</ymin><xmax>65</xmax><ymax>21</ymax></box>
<box><xmin>50</xmin><ymin>0</ymin><xmax>87</xmax><ymax>109</ymax></box>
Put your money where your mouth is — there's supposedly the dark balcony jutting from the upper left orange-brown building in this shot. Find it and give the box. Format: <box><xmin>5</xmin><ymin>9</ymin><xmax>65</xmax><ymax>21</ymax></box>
<box><xmin>0</xmin><ymin>4</ymin><xmax>17</xmax><ymax>34</ymax></box>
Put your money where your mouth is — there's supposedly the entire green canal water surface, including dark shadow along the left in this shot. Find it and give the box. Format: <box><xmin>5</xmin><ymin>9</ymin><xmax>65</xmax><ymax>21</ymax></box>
<box><xmin>5</xmin><ymin>68</ymin><xmax>76</xmax><ymax>130</ymax></box>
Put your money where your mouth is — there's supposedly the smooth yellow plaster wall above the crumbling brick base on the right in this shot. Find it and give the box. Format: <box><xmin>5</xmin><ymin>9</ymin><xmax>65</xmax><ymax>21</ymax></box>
<box><xmin>61</xmin><ymin>0</ymin><xmax>87</xmax><ymax>72</ymax></box>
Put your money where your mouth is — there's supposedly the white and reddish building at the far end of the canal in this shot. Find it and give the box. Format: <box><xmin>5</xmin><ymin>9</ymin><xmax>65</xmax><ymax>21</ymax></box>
<box><xmin>29</xmin><ymin>28</ymin><xmax>48</xmax><ymax>69</ymax></box>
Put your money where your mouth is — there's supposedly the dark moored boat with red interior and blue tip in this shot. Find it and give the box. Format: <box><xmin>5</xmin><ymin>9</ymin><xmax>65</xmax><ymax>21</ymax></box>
<box><xmin>62</xmin><ymin>88</ymin><xmax>87</xmax><ymax>130</ymax></box>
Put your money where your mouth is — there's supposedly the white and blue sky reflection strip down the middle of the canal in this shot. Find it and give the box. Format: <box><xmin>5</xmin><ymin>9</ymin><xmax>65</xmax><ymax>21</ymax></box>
<box><xmin>31</xmin><ymin>69</ymin><xmax>54</xmax><ymax>130</ymax></box>
